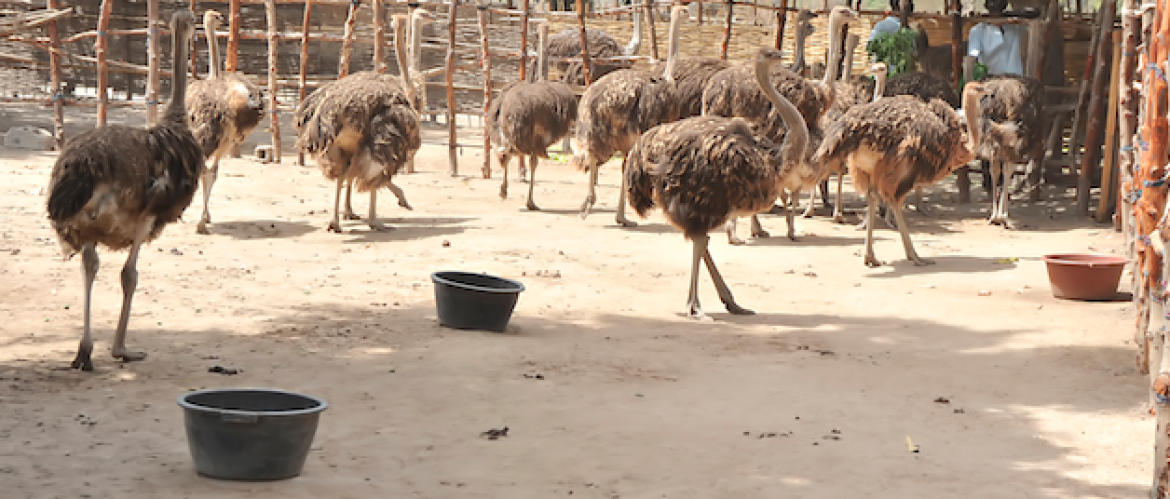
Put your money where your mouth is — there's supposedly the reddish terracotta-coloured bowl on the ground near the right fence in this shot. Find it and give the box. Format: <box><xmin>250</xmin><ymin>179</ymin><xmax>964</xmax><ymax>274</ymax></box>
<box><xmin>1041</xmin><ymin>253</ymin><xmax>1127</xmax><ymax>301</ymax></box>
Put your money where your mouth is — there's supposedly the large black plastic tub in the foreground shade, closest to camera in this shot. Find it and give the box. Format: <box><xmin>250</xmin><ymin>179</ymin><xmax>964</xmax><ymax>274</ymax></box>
<box><xmin>179</xmin><ymin>389</ymin><xmax>326</xmax><ymax>480</ymax></box>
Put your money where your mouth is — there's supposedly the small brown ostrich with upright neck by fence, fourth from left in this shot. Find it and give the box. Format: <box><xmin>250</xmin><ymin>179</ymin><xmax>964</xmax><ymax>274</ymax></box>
<box><xmin>487</xmin><ymin>23</ymin><xmax>577</xmax><ymax>211</ymax></box>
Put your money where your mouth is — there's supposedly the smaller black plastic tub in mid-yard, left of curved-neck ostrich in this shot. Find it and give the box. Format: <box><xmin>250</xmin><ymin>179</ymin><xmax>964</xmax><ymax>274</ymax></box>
<box><xmin>431</xmin><ymin>271</ymin><xmax>524</xmax><ymax>331</ymax></box>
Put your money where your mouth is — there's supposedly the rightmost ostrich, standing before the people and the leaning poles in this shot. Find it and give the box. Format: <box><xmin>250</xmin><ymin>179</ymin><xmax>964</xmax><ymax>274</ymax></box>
<box><xmin>969</xmin><ymin>75</ymin><xmax>1047</xmax><ymax>228</ymax></box>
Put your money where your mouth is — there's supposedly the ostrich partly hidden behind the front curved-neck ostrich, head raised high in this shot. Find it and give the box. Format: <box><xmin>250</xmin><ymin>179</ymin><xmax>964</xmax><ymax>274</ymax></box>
<box><xmin>703</xmin><ymin>6</ymin><xmax>856</xmax><ymax>245</ymax></box>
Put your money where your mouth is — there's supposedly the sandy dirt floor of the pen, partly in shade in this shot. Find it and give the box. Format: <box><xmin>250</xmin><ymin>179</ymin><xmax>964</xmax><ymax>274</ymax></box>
<box><xmin>0</xmin><ymin>103</ymin><xmax>1154</xmax><ymax>499</ymax></box>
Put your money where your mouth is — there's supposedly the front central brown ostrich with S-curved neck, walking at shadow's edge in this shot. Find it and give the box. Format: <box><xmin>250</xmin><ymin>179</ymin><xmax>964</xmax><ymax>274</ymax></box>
<box><xmin>626</xmin><ymin>49</ymin><xmax>808</xmax><ymax>319</ymax></box>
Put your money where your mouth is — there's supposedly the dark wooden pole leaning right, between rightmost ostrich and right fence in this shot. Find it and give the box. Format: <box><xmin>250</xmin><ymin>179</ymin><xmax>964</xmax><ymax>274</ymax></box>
<box><xmin>1076</xmin><ymin>2</ymin><xmax>1116</xmax><ymax>217</ymax></box>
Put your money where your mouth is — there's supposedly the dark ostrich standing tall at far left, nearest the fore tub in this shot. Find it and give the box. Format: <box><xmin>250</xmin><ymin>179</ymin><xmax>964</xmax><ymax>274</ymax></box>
<box><xmin>48</xmin><ymin>11</ymin><xmax>205</xmax><ymax>371</ymax></box>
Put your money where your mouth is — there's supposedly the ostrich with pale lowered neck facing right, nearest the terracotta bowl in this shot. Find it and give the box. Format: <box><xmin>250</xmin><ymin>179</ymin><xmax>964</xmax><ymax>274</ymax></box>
<box><xmin>812</xmin><ymin>83</ymin><xmax>987</xmax><ymax>267</ymax></box>
